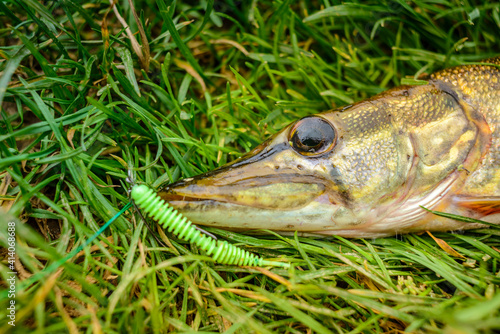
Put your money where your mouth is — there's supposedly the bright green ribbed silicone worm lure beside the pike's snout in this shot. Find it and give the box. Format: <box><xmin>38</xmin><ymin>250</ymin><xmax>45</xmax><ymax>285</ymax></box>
<box><xmin>130</xmin><ymin>185</ymin><xmax>290</xmax><ymax>268</ymax></box>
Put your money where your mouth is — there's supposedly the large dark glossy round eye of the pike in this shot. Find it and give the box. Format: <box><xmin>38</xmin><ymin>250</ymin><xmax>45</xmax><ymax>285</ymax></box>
<box><xmin>289</xmin><ymin>116</ymin><xmax>336</xmax><ymax>156</ymax></box>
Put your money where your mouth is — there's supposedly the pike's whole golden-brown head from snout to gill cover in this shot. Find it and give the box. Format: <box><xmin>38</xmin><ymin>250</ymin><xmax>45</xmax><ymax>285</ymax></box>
<box><xmin>159</xmin><ymin>85</ymin><xmax>487</xmax><ymax>236</ymax></box>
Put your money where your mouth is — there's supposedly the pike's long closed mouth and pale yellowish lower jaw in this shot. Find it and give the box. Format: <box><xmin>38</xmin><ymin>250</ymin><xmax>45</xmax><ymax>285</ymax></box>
<box><xmin>159</xmin><ymin>177</ymin><xmax>335</xmax><ymax>233</ymax></box>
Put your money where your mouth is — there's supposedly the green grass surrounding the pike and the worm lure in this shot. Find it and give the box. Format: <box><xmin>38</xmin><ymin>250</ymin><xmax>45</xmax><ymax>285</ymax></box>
<box><xmin>0</xmin><ymin>0</ymin><xmax>500</xmax><ymax>333</ymax></box>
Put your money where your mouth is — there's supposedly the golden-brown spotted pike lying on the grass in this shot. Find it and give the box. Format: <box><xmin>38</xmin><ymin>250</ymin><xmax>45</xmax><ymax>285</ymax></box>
<box><xmin>159</xmin><ymin>57</ymin><xmax>500</xmax><ymax>238</ymax></box>
